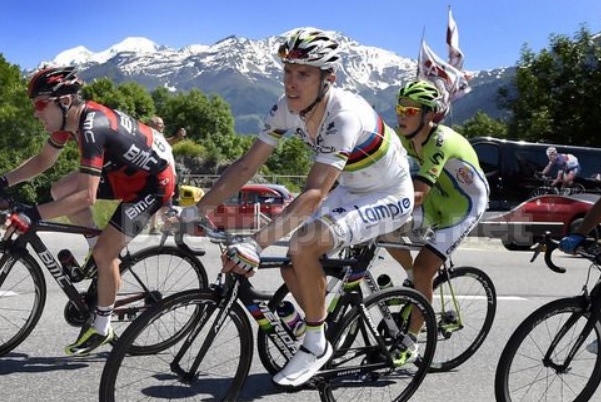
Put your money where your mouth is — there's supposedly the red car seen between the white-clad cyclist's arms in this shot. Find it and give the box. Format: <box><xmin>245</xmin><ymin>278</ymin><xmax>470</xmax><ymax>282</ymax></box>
<box><xmin>208</xmin><ymin>184</ymin><xmax>294</xmax><ymax>229</ymax></box>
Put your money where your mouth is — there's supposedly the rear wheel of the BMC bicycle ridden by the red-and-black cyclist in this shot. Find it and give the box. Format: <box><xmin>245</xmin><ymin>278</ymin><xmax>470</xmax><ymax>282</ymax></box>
<box><xmin>112</xmin><ymin>246</ymin><xmax>208</xmax><ymax>354</ymax></box>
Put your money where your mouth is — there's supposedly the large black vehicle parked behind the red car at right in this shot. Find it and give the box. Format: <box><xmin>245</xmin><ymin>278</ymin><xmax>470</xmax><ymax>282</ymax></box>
<box><xmin>470</xmin><ymin>137</ymin><xmax>601</xmax><ymax>211</ymax></box>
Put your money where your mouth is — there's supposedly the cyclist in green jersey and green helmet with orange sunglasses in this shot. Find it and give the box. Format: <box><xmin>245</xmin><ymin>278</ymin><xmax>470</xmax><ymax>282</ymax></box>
<box><xmin>388</xmin><ymin>81</ymin><xmax>489</xmax><ymax>335</ymax></box>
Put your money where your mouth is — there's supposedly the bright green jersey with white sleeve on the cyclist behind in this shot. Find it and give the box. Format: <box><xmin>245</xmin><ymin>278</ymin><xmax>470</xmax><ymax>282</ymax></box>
<box><xmin>400</xmin><ymin>125</ymin><xmax>489</xmax><ymax>226</ymax></box>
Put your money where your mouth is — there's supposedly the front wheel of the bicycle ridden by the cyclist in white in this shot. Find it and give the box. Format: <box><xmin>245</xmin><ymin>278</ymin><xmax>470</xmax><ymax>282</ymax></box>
<box><xmin>99</xmin><ymin>290</ymin><xmax>253</xmax><ymax>402</ymax></box>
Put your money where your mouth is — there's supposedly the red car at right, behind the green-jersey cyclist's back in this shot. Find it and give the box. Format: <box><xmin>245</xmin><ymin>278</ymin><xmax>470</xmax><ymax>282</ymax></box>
<box><xmin>479</xmin><ymin>193</ymin><xmax>600</xmax><ymax>250</ymax></box>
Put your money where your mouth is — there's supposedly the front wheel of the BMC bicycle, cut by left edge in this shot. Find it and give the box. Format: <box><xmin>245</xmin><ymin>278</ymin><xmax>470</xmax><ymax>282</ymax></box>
<box><xmin>0</xmin><ymin>254</ymin><xmax>46</xmax><ymax>356</ymax></box>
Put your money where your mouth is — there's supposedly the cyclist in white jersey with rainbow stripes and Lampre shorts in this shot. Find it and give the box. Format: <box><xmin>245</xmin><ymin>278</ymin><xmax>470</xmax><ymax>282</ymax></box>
<box><xmin>180</xmin><ymin>28</ymin><xmax>413</xmax><ymax>386</ymax></box>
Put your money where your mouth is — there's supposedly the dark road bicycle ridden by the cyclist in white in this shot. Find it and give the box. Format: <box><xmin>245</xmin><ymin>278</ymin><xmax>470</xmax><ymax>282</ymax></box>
<box><xmin>100</xmin><ymin>223</ymin><xmax>436</xmax><ymax>402</ymax></box>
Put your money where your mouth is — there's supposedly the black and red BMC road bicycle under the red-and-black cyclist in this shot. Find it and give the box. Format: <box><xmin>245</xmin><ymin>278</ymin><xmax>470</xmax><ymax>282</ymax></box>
<box><xmin>0</xmin><ymin>199</ymin><xmax>208</xmax><ymax>356</ymax></box>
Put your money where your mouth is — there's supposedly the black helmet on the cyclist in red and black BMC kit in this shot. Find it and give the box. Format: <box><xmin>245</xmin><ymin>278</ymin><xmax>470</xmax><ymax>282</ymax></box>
<box><xmin>27</xmin><ymin>67</ymin><xmax>83</xmax><ymax>99</ymax></box>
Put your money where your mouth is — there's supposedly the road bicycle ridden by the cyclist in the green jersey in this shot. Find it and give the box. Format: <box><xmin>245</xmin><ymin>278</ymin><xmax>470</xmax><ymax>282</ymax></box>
<box><xmin>257</xmin><ymin>235</ymin><xmax>497</xmax><ymax>374</ymax></box>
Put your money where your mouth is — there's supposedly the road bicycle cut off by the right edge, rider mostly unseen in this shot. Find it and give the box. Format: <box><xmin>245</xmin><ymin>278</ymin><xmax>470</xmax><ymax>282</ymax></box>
<box><xmin>495</xmin><ymin>235</ymin><xmax>601</xmax><ymax>402</ymax></box>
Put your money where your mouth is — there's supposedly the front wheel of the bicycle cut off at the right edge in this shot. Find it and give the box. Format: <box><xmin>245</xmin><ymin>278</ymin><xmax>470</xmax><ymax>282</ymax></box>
<box><xmin>495</xmin><ymin>297</ymin><xmax>601</xmax><ymax>402</ymax></box>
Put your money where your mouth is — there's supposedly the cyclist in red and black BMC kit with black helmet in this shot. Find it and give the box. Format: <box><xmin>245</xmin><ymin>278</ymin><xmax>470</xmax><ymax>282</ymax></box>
<box><xmin>0</xmin><ymin>67</ymin><xmax>175</xmax><ymax>356</ymax></box>
